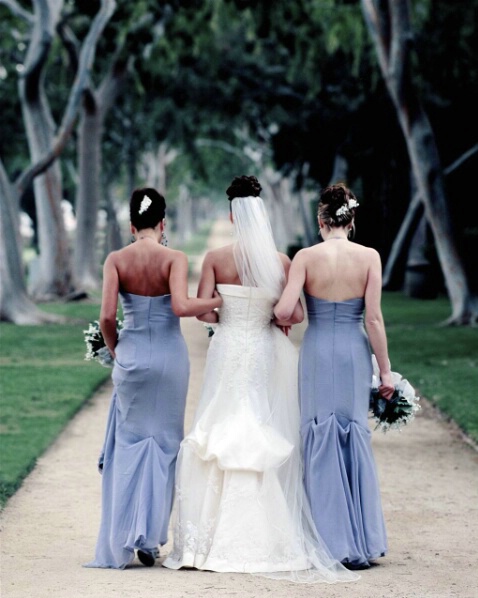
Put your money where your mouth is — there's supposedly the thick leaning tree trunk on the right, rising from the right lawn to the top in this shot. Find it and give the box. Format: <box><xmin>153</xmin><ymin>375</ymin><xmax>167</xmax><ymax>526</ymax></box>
<box><xmin>362</xmin><ymin>0</ymin><xmax>478</xmax><ymax>324</ymax></box>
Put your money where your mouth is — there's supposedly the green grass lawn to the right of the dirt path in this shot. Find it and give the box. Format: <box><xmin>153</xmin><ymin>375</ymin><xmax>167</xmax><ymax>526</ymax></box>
<box><xmin>383</xmin><ymin>293</ymin><xmax>478</xmax><ymax>442</ymax></box>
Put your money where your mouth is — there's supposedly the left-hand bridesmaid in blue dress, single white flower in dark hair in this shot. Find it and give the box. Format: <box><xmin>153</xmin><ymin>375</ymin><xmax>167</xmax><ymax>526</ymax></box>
<box><xmin>85</xmin><ymin>188</ymin><xmax>222</xmax><ymax>569</ymax></box>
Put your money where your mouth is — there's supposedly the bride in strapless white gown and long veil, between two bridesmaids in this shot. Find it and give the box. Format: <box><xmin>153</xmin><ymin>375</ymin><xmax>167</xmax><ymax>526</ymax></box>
<box><xmin>163</xmin><ymin>176</ymin><xmax>358</xmax><ymax>583</ymax></box>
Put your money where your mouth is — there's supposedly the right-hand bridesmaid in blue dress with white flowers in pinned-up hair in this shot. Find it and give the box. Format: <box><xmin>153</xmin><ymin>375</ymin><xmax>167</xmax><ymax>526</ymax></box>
<box><xmin>274</xmin><ymin>184</ymin><xmax>394</xmax><ymax>569</ymax></box>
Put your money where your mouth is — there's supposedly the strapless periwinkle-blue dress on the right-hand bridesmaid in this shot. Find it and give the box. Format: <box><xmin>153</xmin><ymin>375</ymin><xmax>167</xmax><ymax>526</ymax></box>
<box><xmin>299</xmin><ymin>294</ymin><xmax>387</xmax><ymax>567</ymax></box>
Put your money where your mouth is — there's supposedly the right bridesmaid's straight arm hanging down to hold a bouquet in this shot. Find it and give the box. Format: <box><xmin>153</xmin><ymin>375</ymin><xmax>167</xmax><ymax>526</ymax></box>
<box><xmin>365</xmin><ymin>249</ymin><xmax>395</xmax><ymax>399</ymax></box>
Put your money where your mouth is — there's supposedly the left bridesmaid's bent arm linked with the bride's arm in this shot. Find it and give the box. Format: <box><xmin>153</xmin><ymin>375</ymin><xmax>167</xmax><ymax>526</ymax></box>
<box><xmin>169</xmin><ymin>251</ymin><xmax>222</xmax><ymax>317</ymax></box>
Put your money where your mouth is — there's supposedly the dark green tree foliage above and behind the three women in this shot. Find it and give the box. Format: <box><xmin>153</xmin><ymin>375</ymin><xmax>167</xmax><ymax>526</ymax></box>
<box><xmin>0</xmin><ymin>0</ymin><xmax>478</xmax><ymax>300</ymax></box>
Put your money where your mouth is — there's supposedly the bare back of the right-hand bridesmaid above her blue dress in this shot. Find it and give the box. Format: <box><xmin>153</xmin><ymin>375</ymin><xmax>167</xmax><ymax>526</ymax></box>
<box><xmin>301</xmin><ymin>239</ymin><xmax>375</xmax><ymax>301</ymax></box>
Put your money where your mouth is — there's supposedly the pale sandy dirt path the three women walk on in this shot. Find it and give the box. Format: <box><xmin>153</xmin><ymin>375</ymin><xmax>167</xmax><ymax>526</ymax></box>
<box><xmin>0</xmin><ymin>223</ymin><xmax>478</xmax><ymax>598</ymax></box>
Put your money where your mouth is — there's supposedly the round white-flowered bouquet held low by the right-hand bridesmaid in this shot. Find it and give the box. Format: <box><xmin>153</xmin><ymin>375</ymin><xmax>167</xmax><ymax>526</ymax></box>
<box><xmin>370</xmin><ymin>355</ymin><xmax>421</xmax><ymax>432</ymax></box>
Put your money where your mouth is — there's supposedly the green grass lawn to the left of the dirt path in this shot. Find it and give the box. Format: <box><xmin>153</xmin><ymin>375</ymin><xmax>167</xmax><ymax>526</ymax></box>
<box><xmin>0</xmin><ymin>302</ymin><xmax>111</xmax><ymax>505</ymax></box>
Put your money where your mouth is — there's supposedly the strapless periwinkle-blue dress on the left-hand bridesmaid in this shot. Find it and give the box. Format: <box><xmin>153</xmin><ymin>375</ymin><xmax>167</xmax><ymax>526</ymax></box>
<box><xmin>85</xmin><ymin>292</ymin><xmax>189</xmax><ymax>569</ymax></box>
